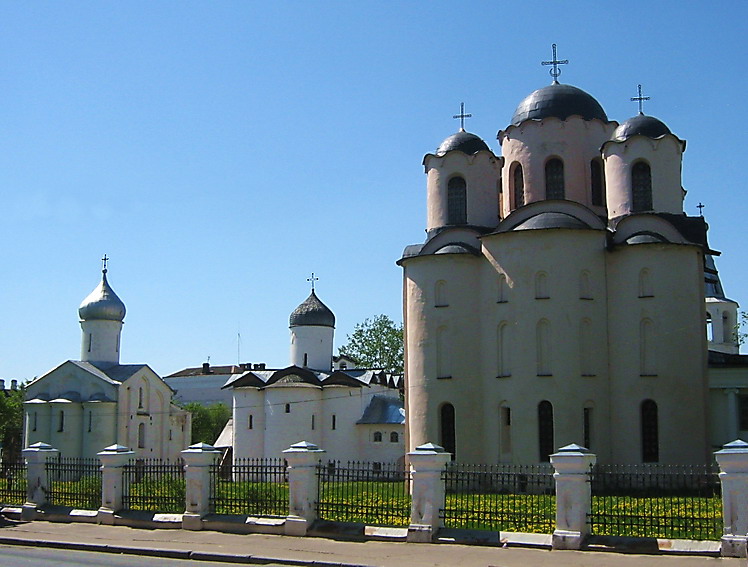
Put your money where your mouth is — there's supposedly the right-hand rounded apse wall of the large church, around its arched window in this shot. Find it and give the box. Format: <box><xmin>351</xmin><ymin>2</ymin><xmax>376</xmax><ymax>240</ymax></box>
<box><xmin>607</xmin><ymin>244</ymin><xmax>708</xmax><ymax>463</ymax></box>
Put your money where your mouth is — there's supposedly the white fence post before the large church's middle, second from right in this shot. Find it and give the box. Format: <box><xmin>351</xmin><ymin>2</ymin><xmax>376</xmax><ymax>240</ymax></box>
<box><xmin>551</xmin><ymin>443</ymin><xmax>597</xmax><ymax>549</ymax></box>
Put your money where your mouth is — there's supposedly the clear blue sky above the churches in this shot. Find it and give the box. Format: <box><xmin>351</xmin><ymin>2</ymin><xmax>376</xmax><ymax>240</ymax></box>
<box><xmin>0</xmin><ymin>0</ymin><xmax>748</xmax><ymax>380</ymax></box>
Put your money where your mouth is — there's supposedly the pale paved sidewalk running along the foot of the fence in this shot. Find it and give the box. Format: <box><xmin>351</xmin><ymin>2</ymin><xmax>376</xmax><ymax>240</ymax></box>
<box><xmin>0</xmin><ymin>521</ymin><xmax>748</xmax><ymax>567</ymax></box>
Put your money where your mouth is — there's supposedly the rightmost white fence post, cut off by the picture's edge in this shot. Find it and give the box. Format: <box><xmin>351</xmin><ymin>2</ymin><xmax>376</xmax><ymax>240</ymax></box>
<box><xmin>714</xmin><ymin>439</ymin><xmax>748</xmax><ymax>557</ymax></box>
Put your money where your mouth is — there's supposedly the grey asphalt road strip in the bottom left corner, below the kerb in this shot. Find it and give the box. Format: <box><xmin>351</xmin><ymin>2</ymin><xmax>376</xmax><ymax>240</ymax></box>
<box><xmin>0</xmin><ymin>545</ymin><xmax>280</xmax><ymax>567</ymax></box>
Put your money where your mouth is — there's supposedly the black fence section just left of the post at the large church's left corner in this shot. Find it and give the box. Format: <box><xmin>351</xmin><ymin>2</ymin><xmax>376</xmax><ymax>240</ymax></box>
<box><xmin>317</xmin><ymin>461</ymin><xmax>411</xmax><ymax>527</ymax></box>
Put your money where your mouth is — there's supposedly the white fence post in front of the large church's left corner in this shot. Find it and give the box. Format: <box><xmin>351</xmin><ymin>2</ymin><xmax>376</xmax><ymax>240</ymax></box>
<box><xmin>408</xmin><ymin>443</ymin><xmax>452</xmax><ymax>543</ymax></box>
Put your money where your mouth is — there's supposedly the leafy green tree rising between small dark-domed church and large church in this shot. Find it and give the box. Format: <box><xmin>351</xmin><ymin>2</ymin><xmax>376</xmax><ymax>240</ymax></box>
<box><xmin>339</xmin><ymin>315</ymin><xmax>403</xmax><ymax>374</ymax></box>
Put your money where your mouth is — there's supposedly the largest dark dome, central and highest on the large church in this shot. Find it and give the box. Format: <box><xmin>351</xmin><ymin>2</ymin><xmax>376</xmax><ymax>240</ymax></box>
<box><xmin>512</xmin><ymin>83</ymin><xmax>608</xmax><ymax>126</ymax></box>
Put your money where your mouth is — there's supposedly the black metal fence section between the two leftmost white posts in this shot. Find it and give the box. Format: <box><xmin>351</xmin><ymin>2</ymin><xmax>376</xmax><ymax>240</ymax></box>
<box><xmin>45</xmin><ymin>457</ymin><xmax>101</xmax><ymax>510</ymax></box>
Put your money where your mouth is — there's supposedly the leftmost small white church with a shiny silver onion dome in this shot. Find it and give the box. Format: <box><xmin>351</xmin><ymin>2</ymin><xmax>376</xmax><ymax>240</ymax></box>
<box><xmin>24</xmin><ymin>262</ymin><xmax>192</xmax><ymax>460</ymax></box>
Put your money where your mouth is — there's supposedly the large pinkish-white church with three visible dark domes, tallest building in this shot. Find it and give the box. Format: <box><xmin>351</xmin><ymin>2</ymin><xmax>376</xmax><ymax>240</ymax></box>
<box><xmin>398</xmin><ymin>64</ymin><xmax>748</xmax><ymax>464</ymax></box>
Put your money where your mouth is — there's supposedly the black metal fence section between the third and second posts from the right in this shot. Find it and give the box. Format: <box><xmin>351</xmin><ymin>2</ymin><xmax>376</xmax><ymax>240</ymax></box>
<box><xmin>440</xmin><ymin>463</ymin><xmax>556</xmax><ymax>533</ymax></box>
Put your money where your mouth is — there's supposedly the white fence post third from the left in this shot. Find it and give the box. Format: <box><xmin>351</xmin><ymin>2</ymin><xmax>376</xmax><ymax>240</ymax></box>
<box><xmin>182</xmin><ymin>443</ymin><xmax>221</xmax><ymax>530</ymax></box>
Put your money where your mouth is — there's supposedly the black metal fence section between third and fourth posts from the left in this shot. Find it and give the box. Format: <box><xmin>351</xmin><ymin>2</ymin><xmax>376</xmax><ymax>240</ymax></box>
<box><xmin>210</xmin><ymin>459</ymin><xmax>288</xmax><ymax>516</ymax></box>
